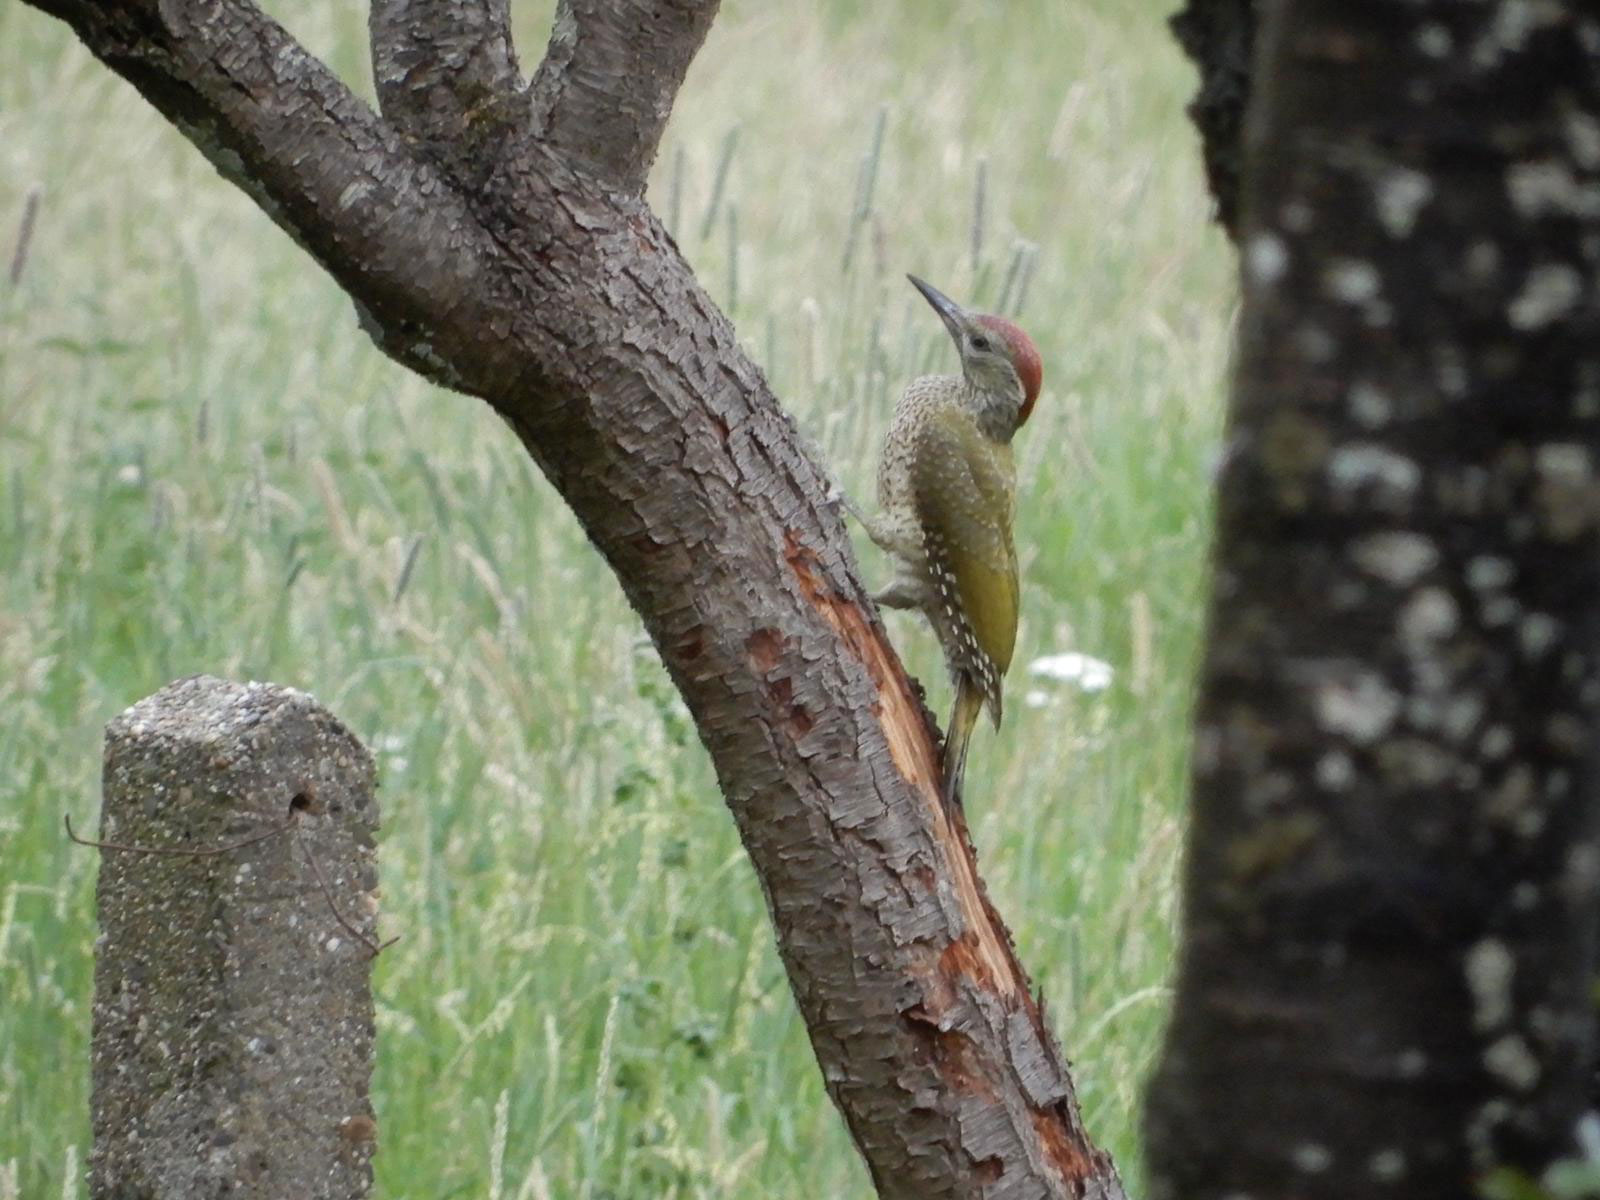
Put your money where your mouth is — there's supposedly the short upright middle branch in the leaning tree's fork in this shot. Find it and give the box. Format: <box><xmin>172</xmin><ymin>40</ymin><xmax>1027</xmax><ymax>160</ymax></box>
<box><xmin>368</xmin><ymin>0</ymin><xmax>528</xmax><ymax>176</ymax></box>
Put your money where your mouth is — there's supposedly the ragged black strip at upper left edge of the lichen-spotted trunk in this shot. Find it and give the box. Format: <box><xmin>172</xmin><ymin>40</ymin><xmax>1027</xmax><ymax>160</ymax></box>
<box><xmin>1171</xmin><ymin>0</ymin><xmax>1258</xmax><ymax>240</ymax></box>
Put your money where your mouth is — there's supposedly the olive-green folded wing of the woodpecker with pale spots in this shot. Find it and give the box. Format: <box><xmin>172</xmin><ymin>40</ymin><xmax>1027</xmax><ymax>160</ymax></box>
<box><xmin>912</xmin><ymin>411</ymin><xmax>1018</xmax><ymax>720</ymax></box>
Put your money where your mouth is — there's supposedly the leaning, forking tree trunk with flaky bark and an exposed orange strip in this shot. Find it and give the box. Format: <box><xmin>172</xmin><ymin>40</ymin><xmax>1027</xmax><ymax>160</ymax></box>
<box><xmin>25</xmin><ymin>0</ymin><xmax>1122</xmax><ymax>1200</ymax></box>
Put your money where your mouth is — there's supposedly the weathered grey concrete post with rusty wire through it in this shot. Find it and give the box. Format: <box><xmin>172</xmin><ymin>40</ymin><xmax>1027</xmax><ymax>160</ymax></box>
<box><xmin>90</xmin><ymin>675</ymin><xmax>378</xmax><ymax>1200</ymax></box>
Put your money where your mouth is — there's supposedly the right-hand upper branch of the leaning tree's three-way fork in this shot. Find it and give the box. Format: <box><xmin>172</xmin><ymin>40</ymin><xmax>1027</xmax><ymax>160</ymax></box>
<box><xmin>533</xmin><ymin>0</ymin><xmax>720</xmax><ymax>192</ymax></box>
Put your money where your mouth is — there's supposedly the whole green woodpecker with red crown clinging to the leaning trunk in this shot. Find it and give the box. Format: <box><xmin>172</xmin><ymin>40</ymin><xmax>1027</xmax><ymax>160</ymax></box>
<box><xmin>858</xmin><ymin>275</ymin><xmax>1043</xmax><ymax>806</ymax></box>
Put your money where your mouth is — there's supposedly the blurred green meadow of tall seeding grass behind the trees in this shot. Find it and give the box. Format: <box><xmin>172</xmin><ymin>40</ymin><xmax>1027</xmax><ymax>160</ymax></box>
<box><xmin>0</xmin><ymin>0</ymin><xmax>1234</xmax><ymax>1200</ymax></box>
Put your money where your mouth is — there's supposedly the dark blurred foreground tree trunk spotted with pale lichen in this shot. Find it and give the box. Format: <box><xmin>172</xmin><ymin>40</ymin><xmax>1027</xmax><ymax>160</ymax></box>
<box><xmin>1147</xmin><ymin>0</ymin><xmax>1600</xmax><ymax>1200</ymax></box>
